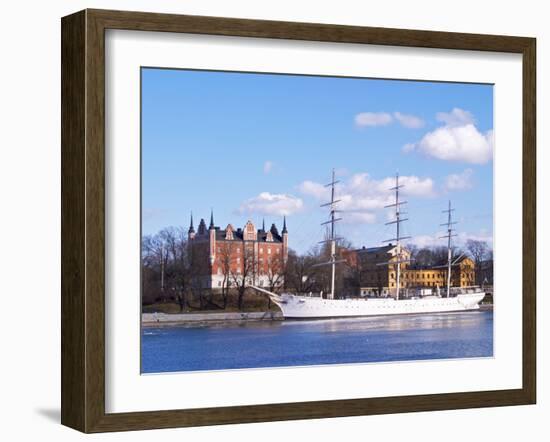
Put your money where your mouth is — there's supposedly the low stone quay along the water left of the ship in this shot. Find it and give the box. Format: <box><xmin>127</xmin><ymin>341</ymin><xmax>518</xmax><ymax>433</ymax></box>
<box><xmin>141</xmin><ymin>311</ymin><xmax>284</xmax><ymax>327</ymax></box>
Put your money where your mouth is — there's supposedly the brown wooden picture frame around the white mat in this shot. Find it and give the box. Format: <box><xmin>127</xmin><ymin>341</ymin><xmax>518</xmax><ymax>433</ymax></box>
<box><xmin>61</xmin><ymin>10</ymin><xmax>536</xmax><ymax>432</ymax></box>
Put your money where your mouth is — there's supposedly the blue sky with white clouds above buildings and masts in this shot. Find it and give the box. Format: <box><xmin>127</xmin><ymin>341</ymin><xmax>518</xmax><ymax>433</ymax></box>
<box><xmin>141</xmin><ymin>68</ymin><xmax>493</xmax><ymax>252</ymax></box>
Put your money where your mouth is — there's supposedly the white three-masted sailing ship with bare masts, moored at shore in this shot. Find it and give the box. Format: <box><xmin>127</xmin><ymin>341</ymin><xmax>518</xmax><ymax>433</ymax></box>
<box><xmin>252</xmin><ymin>170</ymin><xmax>485</xmax><ymax>319</ymax></box>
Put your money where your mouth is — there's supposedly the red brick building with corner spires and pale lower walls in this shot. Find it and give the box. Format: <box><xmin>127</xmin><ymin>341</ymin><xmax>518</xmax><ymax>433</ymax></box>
<box><xmin>188</xmin><ymin>213</ymin><xmax>288</xmax><ymax>290</ymax></box>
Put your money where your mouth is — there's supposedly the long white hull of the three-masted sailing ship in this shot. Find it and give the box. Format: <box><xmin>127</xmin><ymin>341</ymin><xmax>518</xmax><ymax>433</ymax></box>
<box><xmin>270</xmin><ymin>291</ymin><xmax>485</xmax><ymax>319</ymax></box>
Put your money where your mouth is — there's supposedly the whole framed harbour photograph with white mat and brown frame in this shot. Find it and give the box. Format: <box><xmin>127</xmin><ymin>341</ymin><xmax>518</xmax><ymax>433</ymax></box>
<box><xmin>61</xmin><ymin>10</ymin><xmax>536</xmax><ymax>432</ymax></box>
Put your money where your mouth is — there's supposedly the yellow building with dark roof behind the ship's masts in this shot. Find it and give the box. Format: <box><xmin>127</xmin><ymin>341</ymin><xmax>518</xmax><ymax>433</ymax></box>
<box><xmin>352</xmin><ymin>244</ymin><xmax>475</xmax><ymax>296</ymax></box>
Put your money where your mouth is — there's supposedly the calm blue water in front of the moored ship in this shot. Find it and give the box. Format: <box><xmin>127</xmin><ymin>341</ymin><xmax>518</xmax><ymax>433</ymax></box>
<box><xmin>141</xmin><ymin>311</ymin><xmax>493</xmax><ymax>373</ymax></box>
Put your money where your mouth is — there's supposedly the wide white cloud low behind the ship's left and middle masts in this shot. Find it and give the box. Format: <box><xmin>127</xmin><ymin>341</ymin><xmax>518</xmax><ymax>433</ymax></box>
<box><xmin>298</xmin><ymin>173</ymin><xmax>435</xmax><ymax>223</ymax></box>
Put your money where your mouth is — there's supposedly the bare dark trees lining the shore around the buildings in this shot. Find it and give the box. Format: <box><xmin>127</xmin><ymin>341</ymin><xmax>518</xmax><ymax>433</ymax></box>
<box><xmin>142</xmin><ymin>227</ymin><xmax>492</xmax><ymax>312</ymax></box>
